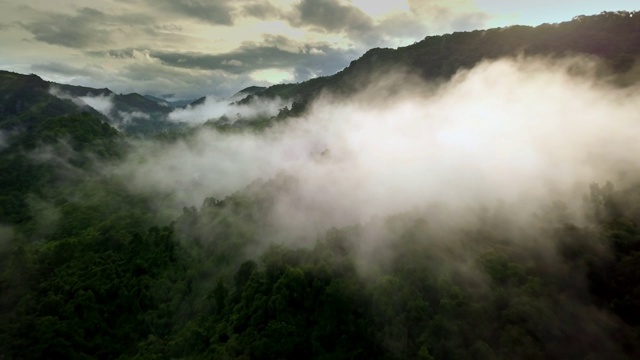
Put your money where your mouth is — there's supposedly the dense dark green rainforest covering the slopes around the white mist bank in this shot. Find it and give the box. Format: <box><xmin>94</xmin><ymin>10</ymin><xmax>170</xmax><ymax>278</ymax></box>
<box><xmin>0</xmin><ymin>9</ymin><xmax>640</xmax><ymax>359</ymax></box>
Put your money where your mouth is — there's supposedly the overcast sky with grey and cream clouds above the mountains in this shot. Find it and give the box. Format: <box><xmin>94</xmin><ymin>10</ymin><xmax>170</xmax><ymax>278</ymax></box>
<box><xmin>0</xmin><ymin>0</ymin><xmax>640</xmax><ymax>98</ymax></box>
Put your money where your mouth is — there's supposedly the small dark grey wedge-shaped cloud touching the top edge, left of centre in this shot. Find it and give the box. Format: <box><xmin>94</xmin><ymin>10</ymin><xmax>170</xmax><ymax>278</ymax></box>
<box><xmin>148</xmin><ymin>0</ymin><xmax>234</xmax><ymax>25</ymax></box>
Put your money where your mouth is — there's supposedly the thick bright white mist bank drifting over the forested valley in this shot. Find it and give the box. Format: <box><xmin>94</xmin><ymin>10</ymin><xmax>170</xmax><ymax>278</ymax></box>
<box><xmin>112</xmin><ymin>59</ymin><xmax>640</xmax><ymax>240</ymax></box>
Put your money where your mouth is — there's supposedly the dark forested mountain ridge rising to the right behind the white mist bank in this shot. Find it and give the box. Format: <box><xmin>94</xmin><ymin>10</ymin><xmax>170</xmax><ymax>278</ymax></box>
<box><xmin>245</xmin><ymin>11</ymin><xmax>640</xmax><ymax>109</ymax></box>
